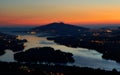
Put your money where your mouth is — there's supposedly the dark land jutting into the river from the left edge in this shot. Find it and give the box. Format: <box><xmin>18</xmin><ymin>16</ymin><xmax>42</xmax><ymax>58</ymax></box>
<box><xmin>0</xmin><ymin>33</ymin><xmax>27</xmax><ymax>55</ymax></box>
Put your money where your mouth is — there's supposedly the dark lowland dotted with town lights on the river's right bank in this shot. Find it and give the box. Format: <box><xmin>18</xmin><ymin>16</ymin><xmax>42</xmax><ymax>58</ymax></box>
<box><xmin>47</xmin><ymin>28</ymin><xmax>120</xmax><ymax>62</ymax></box>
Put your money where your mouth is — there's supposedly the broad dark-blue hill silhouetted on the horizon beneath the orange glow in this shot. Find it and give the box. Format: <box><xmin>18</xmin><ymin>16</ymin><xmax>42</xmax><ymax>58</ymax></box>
<box><xmin>32</xmin><ymin>22</ymin><xmax>89</xmax><ymax>35</ymax></box>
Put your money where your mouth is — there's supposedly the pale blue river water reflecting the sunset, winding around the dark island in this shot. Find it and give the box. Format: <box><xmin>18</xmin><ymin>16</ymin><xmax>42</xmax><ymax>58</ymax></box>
<box><xmin>0</xmin><ymin>35</ymin><xmax>120</xmax><ymax>71</ymax></box>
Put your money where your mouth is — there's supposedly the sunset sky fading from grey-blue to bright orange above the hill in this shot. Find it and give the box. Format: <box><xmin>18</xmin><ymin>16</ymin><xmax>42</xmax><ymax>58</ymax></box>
<box><xmin>0</xmin><ymin>0</ymin><xmax>120</xmax><ymax>25</ymax></box>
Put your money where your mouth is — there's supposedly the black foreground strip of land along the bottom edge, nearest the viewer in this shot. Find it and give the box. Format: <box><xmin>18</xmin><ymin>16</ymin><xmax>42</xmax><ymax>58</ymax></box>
<box><xmin>0</xmin><ymin>62</ymin><xmax>120</xmax><ymax>75</ymax></box>
